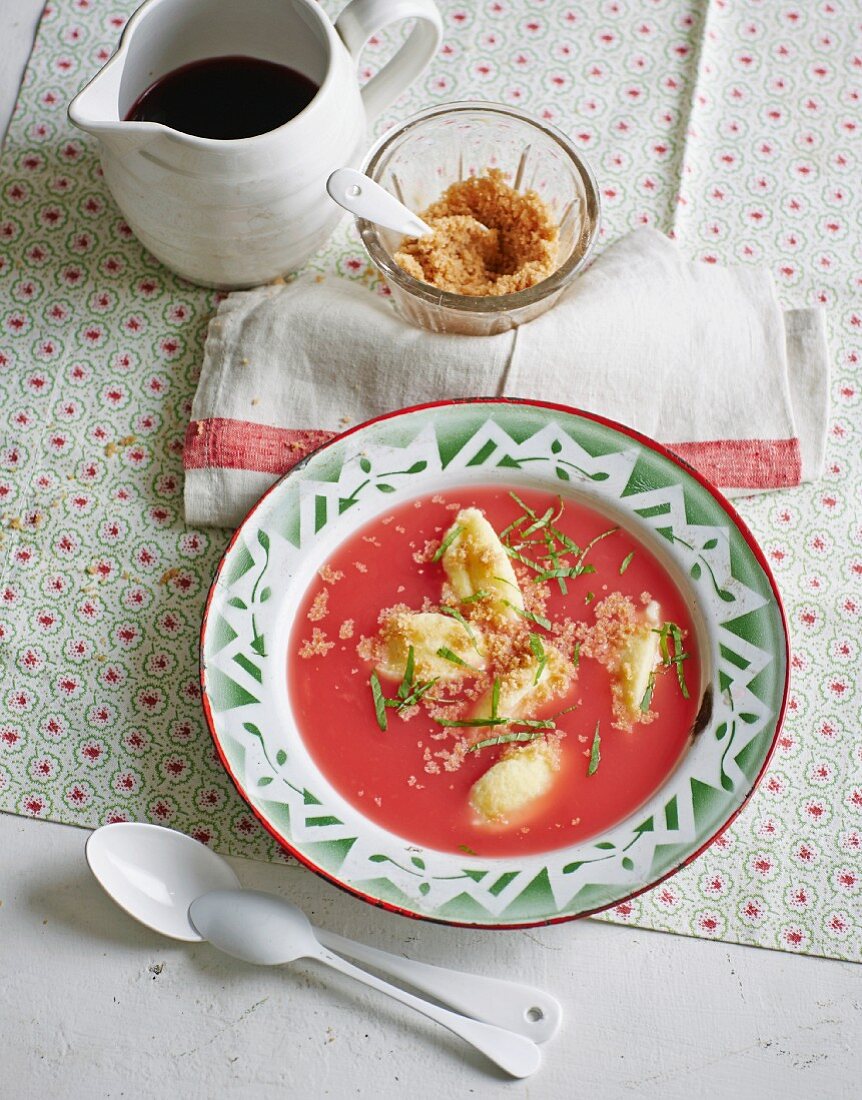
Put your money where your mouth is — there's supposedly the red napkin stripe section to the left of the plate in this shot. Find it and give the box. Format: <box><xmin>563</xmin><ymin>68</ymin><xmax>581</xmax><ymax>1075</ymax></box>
<box><xmin>183</xmin><ymin>417</ymin><xmax>338</xmax><ymax>474</ymax></box>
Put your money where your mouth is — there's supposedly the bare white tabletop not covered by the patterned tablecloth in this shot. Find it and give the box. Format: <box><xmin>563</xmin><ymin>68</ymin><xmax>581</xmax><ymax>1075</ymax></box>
<box><xmin>0</xmin><ymin>0</ymin><xmax>862</xmax><ymax>1100</ymax></box>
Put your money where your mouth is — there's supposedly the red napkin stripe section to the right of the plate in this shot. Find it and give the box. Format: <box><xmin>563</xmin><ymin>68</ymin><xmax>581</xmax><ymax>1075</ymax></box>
<box><xmin>666</xmin><ymin>438</ymin><xmax>803</xmax><ymax>488</ymax></box>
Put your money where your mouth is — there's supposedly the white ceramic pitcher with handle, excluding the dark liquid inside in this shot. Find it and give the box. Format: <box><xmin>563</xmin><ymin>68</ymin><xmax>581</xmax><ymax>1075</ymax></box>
<box><xmin>69</xmin><ymin>0</ymin><xmax>441</xmax><ymax>287</ymax></box>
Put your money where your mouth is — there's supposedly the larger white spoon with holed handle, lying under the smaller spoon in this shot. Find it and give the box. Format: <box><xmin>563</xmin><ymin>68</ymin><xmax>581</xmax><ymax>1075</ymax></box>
<box><xmin>87</xmin><ymin>822</ymin><xmax>562</xmax><ymax>1043</ymax></box>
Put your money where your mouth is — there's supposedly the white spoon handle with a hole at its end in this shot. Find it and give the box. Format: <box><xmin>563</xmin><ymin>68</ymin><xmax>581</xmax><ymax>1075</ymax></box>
<box><xmin>314</xmin><ymin>928</ymin><xmax>563</xmax><ymax>1043</ymax></box>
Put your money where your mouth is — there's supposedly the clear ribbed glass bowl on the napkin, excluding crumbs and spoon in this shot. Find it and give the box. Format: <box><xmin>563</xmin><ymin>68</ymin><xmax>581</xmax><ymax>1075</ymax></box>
<box><xmin>356</xmin><ymin>102</ymin><xmax>599</xmax><ymax>336</ymax></box>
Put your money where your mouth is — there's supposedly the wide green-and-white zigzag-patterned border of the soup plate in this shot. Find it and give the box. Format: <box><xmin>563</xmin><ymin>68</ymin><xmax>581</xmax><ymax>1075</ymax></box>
<box><xmin>205</xmin><ymin>404</ymin><xmax>784</xmax><ymax>923</ymax></box>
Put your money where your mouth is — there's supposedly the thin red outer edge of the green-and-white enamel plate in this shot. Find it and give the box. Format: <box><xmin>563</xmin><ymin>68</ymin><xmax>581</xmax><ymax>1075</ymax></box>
<box><xmin>199</xmin><ymin>397</ymin><xmax>791</xmax><ymax>931</ymax></box>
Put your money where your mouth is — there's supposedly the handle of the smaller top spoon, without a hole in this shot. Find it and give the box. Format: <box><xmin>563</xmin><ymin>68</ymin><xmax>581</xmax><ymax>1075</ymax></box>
<box><xmin>311</xmin><ymin>946</ymin><xmax>542</xmax><ymax>1077</ymax></box>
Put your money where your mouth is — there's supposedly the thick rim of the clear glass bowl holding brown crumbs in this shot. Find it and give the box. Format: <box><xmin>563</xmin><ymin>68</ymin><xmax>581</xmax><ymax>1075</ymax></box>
<box><xmin>355</xmin><ymin>100</ymin><xmax>601</xmax><ymax>314</ymax></box>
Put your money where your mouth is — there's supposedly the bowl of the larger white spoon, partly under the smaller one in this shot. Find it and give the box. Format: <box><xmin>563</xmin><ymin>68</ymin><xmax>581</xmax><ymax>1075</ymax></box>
<box><xmin>86</xmin><ymin>822</ymin><xmax>240</xmax><ymax>943</ymax></box>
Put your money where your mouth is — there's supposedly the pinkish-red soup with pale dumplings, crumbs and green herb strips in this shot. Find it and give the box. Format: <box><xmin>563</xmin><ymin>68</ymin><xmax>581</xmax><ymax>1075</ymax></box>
<box><xmin>287</xmin><ymin>486</ymin><xmax>701</xmax><ymax>857</ymax></box>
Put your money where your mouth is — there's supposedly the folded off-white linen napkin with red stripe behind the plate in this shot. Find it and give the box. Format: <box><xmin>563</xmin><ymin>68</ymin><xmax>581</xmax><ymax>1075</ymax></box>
<box><xmin>184</xmin><ymin>229</ymin><xmax>829</xmax><ymax>527</ymax></box>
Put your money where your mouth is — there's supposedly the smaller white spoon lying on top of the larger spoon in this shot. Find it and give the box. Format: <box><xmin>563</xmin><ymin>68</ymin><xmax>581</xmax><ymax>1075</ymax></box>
<box><xmin>189</xmin><ymin>890</ymin><xmax>542</xmax><ymax>1077</ymax></box>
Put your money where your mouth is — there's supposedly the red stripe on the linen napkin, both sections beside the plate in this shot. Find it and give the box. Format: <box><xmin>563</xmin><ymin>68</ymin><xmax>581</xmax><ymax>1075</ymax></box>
<box><xmin>183</xmin><ymin>417</ymin><xmax>802</xmax><ymax>488</ymax></box>
